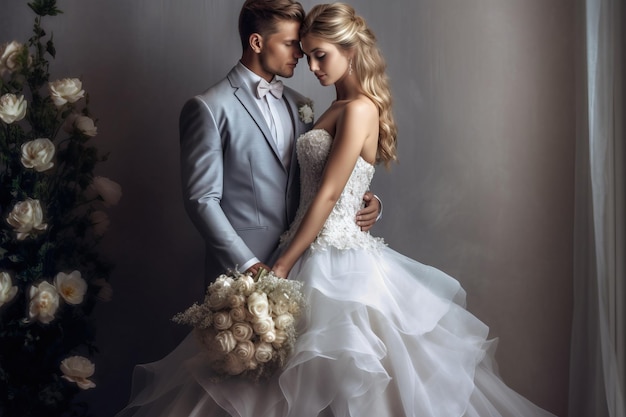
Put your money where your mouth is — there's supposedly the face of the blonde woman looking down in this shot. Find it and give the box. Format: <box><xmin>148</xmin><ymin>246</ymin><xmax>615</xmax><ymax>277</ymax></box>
<box><xmin>301</xmin><ymin>35</ymin><xmax>350</xmax><ymax>85</ymax></box>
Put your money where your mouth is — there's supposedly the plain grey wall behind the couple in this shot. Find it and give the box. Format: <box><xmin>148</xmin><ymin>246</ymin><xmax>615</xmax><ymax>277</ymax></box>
<box><xmin>0</xmin><ymin>0</ymin><xmax>575</xmax><ymax>417</ymax></box>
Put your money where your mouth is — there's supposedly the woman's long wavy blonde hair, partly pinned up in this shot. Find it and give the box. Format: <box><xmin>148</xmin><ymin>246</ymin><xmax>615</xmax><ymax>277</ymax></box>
<box><xmin>300</xmin><ymin>3</ymin><xmax>397</xmax><ymax>167</ymax></box>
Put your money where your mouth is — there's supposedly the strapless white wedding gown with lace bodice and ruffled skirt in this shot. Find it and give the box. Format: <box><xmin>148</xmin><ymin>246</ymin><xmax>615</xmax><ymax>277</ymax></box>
<box><xmin>120</xmin><ymin>129</ymin><xmax>552</xmax><ymax>417</ymax></box>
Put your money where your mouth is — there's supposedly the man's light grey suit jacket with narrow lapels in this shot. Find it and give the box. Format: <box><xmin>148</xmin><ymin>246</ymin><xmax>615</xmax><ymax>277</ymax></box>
<box><xmin>179</xmin><ymin>65</ymin><xmax>312</xmax><ymax>282</ymax></box>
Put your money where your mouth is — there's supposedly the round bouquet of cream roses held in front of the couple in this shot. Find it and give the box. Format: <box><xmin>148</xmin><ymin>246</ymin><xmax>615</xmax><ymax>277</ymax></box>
<box><xmin>173</xmin><ymin>270</ymin><xmax>304</xmax><ymax>380</ymax></box>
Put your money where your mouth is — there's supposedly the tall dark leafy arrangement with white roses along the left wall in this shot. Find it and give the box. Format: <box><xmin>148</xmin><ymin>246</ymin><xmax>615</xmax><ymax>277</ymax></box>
<box><xmin>0</xmin><ymin>0</ymin><xmax>122</xmax><ymax>417</ymax></box>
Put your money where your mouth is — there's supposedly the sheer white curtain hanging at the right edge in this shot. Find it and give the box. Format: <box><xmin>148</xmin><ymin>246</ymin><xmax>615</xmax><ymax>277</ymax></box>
<box><xmin>569</xmin><ymin>0</ymin><xmax>626</xmax><ymax>417</ymax></box>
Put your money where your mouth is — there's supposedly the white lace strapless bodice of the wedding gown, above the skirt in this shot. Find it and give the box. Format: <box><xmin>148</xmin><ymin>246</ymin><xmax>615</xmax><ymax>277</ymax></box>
<box><xmin>281</xmin><ymin>129</ymin><xmax>385</xmax><ymax>250</ymax></box>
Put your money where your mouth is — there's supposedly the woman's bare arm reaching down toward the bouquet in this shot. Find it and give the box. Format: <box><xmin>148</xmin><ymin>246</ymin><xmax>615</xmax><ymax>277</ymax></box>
<box><xmin>272</xmin><ymin>99</ymin><xmax>378</xmax><ymax>278</ymax></box>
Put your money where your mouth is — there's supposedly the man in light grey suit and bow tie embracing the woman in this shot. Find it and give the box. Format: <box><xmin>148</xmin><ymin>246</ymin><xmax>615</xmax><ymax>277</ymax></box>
<box><xmin>179</xmin><ymin>0</ymin><xmax>380</xmax><ymax>283</ymax></box>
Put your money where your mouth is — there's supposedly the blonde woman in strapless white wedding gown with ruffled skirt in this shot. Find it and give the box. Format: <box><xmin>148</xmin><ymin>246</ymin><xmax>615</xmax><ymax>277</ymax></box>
<box><xmin>121</xmin><ymin>3</ymin><xmax>552</xmax><ymax>417</ymax></box>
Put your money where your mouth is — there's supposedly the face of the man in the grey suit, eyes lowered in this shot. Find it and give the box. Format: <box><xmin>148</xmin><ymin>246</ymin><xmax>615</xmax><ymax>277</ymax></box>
<box><xmin>259</xmin><ymin>20</ymin><xmax>303</xmax><ymax>78</ymax></box>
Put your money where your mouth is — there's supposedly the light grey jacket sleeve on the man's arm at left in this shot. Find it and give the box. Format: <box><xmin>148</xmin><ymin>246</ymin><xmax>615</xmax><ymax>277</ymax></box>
<box><xmin>179</xmin><ymin>97</ymin><xmax>255</xmax><ymax>270</ymax></box>
